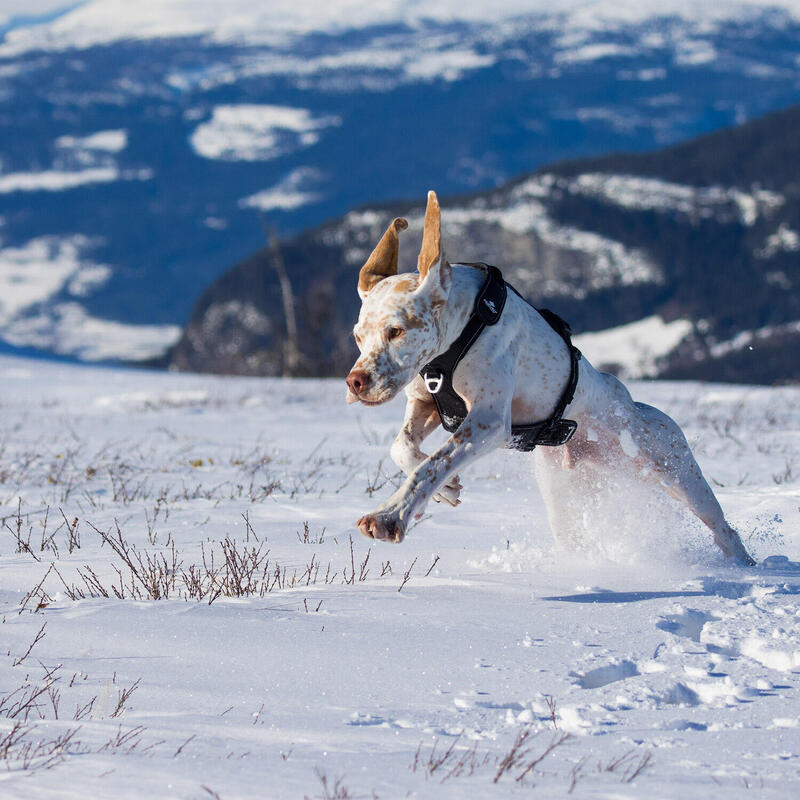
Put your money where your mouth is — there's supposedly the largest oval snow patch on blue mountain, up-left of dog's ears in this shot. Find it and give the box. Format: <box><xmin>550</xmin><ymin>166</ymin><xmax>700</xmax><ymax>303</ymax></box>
<box><xmin>190</xmin><ymin>103</ymin><xmax>341</xmax><ymax>161</ymax></box>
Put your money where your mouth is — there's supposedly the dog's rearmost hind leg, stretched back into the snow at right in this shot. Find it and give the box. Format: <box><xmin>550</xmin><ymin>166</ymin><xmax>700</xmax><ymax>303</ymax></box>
<box><xmin>620</xmin><ymin>403</ymin><xmax>755</xmax><ymax>566</ymax></box>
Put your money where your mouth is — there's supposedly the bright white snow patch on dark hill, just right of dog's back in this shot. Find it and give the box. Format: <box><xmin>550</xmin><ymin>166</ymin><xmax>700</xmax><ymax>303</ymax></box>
<box><xmin>574</xmin><ymin>316</ymin><xmax>692</xmax><ymax>378</ymax></box>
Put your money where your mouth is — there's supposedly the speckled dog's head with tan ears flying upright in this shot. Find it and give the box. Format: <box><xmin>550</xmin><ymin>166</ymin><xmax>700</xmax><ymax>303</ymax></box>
<box><xmin>346</xmin><ymin>192</ymin><xmax>452</xmax><ymax>405</ymax></box>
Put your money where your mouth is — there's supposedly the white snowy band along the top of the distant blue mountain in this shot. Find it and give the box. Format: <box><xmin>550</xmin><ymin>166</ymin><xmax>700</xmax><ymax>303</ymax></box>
<box><xmin>0</xmin><ymin>0</ymin><xmax>800</xmax><ymax>55</ymax></box>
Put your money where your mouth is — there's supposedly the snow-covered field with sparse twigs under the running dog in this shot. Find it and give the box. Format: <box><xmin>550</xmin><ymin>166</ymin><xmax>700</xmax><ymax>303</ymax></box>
<box><xmin>0</xmin><ymin>358</ymin><xmax>800</xmax><ymax>800</ymax></box>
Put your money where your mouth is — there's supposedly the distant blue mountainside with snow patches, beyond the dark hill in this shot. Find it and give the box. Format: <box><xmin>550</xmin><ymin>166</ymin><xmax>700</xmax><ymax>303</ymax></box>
<box><xmin>0</xmin><ymin>0</ymin><xmax>800</xmax><ymax>359</ymax></box>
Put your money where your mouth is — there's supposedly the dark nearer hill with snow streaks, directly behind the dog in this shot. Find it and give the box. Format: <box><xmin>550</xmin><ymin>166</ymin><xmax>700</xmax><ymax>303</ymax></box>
<box><xmin>172</xmin><ymin>106</ymin><xmax>800</xmax><ymax>383</ymax></box>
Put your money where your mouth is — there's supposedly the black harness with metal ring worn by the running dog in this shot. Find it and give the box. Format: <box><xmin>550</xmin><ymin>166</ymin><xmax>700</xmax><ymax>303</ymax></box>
<box><xmin>419</xmin><ymin>264</ymin><xmax>581</xmax><ymax>451</ymax></box>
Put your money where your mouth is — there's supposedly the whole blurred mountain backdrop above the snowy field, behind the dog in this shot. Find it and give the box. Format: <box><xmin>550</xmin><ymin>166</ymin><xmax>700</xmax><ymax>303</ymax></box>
<box><xmin>0</xmin><ymin>0</ymin><xmax>800</xmax><ymax>384</ymax></box>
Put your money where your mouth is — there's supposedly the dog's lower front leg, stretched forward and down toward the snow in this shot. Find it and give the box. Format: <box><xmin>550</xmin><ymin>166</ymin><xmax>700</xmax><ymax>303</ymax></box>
<box><xmin>356</xmin><ymin>400</ymin><xmax>511</xmax><ymax>542</ymax></box>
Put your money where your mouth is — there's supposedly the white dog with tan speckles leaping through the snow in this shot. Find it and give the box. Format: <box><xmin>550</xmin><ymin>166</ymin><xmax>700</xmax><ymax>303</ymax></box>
<box><xmin>346</xmin><ymin>192</ymin><xmax>755</xmax><ymax>565</ymax></box>
